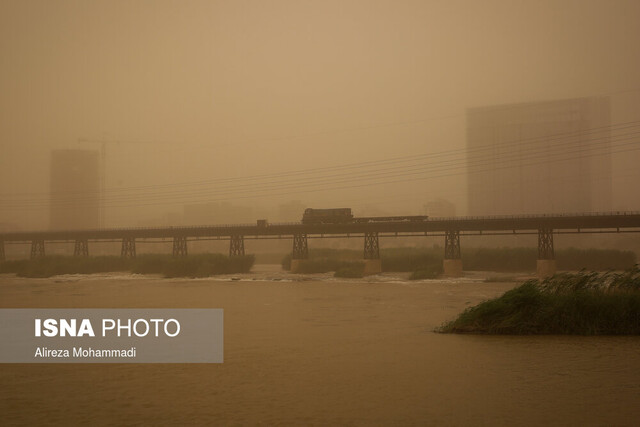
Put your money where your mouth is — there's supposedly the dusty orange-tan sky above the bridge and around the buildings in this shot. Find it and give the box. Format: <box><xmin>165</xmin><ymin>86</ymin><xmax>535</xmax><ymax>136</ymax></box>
<box><xmin>0</xmin><ymin>1</ymin><xmax>640</xmax><ymax>228</ymax></box>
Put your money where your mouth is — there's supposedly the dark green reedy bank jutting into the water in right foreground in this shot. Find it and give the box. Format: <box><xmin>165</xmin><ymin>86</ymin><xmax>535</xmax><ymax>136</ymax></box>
<box><xmin>437</xmin><ymin>266</ymin><xmax>640</xmax><ymax>335</ymax></box>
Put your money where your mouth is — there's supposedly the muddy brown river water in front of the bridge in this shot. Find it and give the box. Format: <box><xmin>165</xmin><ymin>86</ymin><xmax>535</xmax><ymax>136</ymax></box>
<box><xmin>0</xmin><ymin>268</ymin><xmax>640</xmax><ymax>426</ymax></box>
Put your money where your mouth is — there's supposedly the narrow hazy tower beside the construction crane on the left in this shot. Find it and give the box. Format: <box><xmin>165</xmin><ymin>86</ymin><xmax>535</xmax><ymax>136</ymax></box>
<box><xmin>49</xmin><ymin>150</ymin><xmax>100</xmax><ymax>230</ymax></box>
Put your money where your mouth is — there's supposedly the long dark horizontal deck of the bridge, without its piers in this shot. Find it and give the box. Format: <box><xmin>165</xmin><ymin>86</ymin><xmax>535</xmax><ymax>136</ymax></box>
<box><xmin>0</xmin><ymin>212</ymin><xmax>640</xmax><ymax>242</ymax></box>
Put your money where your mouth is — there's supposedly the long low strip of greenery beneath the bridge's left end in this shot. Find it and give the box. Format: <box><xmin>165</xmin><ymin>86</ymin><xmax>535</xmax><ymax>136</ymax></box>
<box><xmin>0</xmin><ymin>254</ymin><xmax>254</xmax><ymax>277</ymax></box>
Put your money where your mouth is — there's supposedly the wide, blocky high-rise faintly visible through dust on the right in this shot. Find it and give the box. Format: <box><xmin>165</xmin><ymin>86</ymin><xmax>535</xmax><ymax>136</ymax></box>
<box><xmin>467</xmin><ymin>97</ymin><xmax>612</xmax><ymax>215</ymax></box>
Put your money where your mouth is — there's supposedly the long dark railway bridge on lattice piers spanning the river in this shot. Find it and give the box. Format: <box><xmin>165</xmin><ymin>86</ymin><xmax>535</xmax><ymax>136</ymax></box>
<box><xmin>0</xmin><ymin>212</ymin><xmax>640</xmax><ymax>277</ymax></box>
